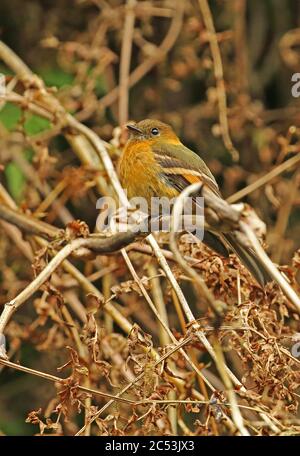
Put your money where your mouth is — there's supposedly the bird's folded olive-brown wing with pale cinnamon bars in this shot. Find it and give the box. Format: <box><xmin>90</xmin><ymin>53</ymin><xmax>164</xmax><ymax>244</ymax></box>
<box><xmin>152</xmin><ymin>142</ymin><xmax>220</xmax><ymax>196</ymax></box>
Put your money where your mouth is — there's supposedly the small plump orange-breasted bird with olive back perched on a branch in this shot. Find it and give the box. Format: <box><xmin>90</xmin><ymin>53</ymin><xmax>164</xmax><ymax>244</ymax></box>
<box><xmin>119</xmin><ymin>119</ymin><xmax>271</xmax><ymax>287</ymax></box>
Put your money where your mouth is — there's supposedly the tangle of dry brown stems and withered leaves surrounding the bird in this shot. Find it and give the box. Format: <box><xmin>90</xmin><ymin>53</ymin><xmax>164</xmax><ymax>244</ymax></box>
<box><xmin>0</xmin><ymin>0</ymin><xmax>300</xmax><ymax>436</ymax></box>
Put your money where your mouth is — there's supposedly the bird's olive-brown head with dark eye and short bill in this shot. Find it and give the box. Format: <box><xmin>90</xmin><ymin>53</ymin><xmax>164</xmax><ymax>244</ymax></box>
<box><xmin>127</xmin><ymin>119</ymin><xmax>180</xmax><ymax>144</ymax></box>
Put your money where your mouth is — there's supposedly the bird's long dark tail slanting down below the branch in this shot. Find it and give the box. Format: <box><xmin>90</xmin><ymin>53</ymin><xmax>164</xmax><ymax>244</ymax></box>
<box><xmin>223</xmin><ymin>233</ymin><xmax>272</xmax><ymax>287</ymax></box>
